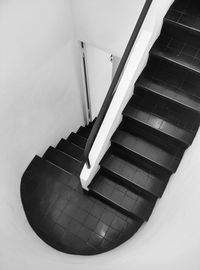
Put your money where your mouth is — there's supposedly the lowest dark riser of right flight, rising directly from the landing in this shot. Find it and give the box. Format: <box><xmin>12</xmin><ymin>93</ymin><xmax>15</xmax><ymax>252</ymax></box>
<box><xmin>89</xmin><ymin>190</ymin><xmax>146</xmax><ymax>222</ymax></box>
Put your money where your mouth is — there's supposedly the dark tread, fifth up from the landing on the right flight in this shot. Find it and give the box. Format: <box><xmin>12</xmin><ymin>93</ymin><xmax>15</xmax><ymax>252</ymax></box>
<box><xmin>137</xmin><ymin>77</ymin><xmax>200</xmax><ymax>113</ymax></box>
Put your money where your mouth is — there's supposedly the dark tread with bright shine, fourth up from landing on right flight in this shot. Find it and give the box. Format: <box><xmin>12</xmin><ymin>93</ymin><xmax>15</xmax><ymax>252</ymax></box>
<box><xmin>123</xmin><ymin>105</ymin><xmax>194</xmax><ymax>146</ymax></box>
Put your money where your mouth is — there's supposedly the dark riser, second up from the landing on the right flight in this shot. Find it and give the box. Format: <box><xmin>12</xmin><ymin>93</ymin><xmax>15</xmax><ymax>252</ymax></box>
<box><xmin>101</xmin><ymin>166</ymin><xmax>161</xmax><ymax>199</ymax></box>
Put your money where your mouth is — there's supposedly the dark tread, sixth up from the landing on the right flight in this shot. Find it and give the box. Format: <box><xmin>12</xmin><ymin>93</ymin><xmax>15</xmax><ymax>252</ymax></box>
<box><xmin>150</xmin><ymin>37</ymin><xmax>200</xmax><ymax>74</ymax></box>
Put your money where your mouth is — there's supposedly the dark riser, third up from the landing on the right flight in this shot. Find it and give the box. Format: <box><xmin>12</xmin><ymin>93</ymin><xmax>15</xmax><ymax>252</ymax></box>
<box><xmin>112</xmin><ymin>142</ymin><xmax>173</xmax><ymax>181</ymax></box>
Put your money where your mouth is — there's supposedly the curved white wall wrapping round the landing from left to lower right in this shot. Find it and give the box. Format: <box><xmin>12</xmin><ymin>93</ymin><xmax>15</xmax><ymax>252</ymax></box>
<box><xmin>0</xmin><ymin>0</ymin><xmax>200</xmax><ymax>270</ymax></box>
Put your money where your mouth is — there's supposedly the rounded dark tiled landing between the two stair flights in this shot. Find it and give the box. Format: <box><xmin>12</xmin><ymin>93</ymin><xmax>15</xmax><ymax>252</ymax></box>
<box><xmin>21</xmin><ymin>156</ymin><xmax>141</xmax><ymax>255</ymax></box>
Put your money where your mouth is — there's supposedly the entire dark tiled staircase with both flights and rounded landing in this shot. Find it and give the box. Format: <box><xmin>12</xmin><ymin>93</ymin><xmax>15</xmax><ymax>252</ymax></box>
<box><xmin>21</xmin><ymin>0</ymin><xmax>200</xmax><ymax>255</ymax></box>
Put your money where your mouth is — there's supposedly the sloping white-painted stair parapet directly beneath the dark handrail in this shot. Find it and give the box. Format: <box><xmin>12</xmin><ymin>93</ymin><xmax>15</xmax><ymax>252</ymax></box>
<box><xmin>80</xmin><ymin>0</ymin><xmax>173</xmax><ymax>190</ymax></box>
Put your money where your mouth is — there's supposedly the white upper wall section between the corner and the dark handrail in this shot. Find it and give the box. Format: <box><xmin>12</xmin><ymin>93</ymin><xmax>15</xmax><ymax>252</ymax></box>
<box><xmin>72</xmin><ymin>0</ymin><xmax>145</xmax><ymax>57</ymax></box>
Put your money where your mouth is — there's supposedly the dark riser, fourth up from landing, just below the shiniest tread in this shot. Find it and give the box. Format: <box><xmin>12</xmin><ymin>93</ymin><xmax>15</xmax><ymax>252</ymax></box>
<box><xmin>121</xmin><ymin>116</ymin><xmax>188</xmax><ymax>157</ymax></box>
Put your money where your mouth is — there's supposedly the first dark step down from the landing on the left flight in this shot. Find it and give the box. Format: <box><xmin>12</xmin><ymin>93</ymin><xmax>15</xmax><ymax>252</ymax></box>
<box><xmin>43</xmin><ymin>146</ymin><xmax>83</xmax><ymax>175</ymax></box>
